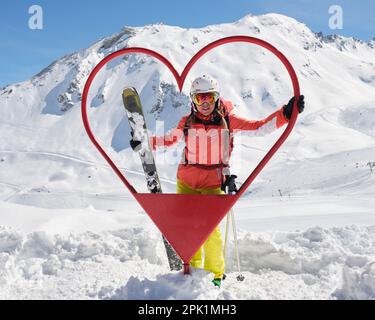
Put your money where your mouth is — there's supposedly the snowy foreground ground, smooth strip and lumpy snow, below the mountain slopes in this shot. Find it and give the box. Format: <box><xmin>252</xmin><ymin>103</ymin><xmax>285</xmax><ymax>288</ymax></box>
<box><xmin>0</xmin><ymin>192</ymin><xmax>375</xmax><ymax>299</ymax></box>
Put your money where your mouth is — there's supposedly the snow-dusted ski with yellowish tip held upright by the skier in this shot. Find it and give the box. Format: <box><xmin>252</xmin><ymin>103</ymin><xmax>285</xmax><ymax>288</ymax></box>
<box><xmin>122</xmin><ymin>87</ymin><xmax>182</xmax><ymax>271</ymax></box>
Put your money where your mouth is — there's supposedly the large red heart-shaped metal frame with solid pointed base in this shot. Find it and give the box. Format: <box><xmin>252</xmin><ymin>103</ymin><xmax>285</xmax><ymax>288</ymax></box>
<box><xmin>81</xmin><ymin>36</ymin><xmax>300</xmax><ymax>270</ymax></box>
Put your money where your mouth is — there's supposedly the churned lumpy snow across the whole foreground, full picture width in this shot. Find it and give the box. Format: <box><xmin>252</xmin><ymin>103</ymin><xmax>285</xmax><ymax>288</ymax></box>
<box><xmin>0</xmin><ymin>222</ymin><xmax>375</xmax><ymax>300</ymax></box>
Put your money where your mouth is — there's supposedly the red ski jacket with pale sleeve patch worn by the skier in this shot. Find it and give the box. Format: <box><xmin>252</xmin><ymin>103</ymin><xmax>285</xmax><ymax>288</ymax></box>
<box><xmin>151</xmin><ymin>99</ymin><xmax>288</xmax><ymax>189</ymax></box>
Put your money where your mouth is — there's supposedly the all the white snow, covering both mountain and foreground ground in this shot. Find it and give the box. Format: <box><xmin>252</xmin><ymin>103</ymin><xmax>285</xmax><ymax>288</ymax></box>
<box><xmin>0</xmin><ymin>14</ymin><xmax>375</xmax><ymax>300</ymax></box>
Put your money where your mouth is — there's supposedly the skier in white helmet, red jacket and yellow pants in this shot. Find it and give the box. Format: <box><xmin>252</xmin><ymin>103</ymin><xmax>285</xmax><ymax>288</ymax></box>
<box><xmin>131</xmin><ymin>75</ymin><xmax>305</xmax><ymax>286</ymax></box>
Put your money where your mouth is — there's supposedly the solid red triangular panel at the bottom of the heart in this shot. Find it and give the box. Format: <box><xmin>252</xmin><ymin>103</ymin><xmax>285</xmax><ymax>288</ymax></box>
<box><xmin>134</xmin><ymin>193</ymin><xmax>237</xmax><ymax>264</ymax></box>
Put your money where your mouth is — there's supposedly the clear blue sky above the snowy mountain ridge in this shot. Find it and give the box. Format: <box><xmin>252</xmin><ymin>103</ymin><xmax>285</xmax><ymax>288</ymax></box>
<box><xmin>0</xmin><ymin>0</ymin><xmax>375</xmax><ymax>87</ymax></box>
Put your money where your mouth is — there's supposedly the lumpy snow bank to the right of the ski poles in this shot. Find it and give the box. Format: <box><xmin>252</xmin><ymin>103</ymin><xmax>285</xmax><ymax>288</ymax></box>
<box><xmin>227</xmin><ymin>225</ymin><xmax>375</xmax><ymax>277</ymax></box>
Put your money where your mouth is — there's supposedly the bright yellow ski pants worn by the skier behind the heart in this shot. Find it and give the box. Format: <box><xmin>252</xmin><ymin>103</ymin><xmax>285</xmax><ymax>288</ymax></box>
<box><xmin>177</xmin><ymin>180</ymin><xmax>225</xmax><ymax>279</ymax></box>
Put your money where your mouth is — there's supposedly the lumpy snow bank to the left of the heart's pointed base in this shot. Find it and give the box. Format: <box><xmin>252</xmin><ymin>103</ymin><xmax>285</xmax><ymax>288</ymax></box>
<box><xmin>0</xmin><ymin>227</ymin><xmax>168</xmax><ymax>299</ymax></box>
